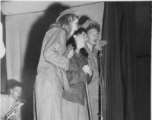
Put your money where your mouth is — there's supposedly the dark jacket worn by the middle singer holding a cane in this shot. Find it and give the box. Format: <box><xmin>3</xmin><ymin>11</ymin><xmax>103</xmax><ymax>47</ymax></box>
<box><xmin>63</xmin><ymin>52</ymin><xmax>91</xmax><ymax>105</ymax></box>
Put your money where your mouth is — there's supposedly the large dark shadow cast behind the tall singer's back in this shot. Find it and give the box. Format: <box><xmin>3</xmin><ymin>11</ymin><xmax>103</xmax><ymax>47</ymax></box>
<box><xmin>22</xmin><ymin>3</ymin><xmax>69</xmax><ymax>120</ymax></box>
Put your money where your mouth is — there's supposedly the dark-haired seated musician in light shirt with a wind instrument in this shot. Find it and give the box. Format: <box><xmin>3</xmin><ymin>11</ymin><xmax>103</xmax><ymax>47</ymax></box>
<box><xmin>0</xmin><ymin>81</ymin><xmax>23</xmax><ymax>120</ymax></box>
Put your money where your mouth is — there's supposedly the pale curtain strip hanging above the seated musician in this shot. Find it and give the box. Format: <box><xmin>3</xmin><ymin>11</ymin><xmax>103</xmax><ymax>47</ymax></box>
<box><xmin>6</xmin><ymin>16</ymin><xmax>21</xmax><ymax>81</ymax></box>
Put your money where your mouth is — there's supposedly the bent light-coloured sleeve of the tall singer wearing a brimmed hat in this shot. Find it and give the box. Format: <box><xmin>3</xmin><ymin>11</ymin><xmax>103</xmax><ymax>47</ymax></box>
<box><xmin>43</xmin><ymin>30</ymin><xmax>69</xmax><ymax>70</ymax></box>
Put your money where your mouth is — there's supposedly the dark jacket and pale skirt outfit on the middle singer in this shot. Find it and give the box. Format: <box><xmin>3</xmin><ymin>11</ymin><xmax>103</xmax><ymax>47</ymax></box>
<box><xmin>62</xmin><ymin>52</ymin><xmax>91</xmax><ymax>120</ymax></box>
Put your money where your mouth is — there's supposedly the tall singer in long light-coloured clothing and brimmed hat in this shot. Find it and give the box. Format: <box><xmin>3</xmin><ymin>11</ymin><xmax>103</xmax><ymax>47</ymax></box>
<box><xmin>34</xmin><ymin>9</ymin><xmax>79</xmax><ymax>120</ymax></box>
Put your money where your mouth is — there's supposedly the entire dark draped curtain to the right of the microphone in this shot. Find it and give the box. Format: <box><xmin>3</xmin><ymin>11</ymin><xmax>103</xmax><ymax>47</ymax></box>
<box><xmin>103</xmin><ymin>2</ymin><xmax>136</xmax><ymax>120</ymax></box>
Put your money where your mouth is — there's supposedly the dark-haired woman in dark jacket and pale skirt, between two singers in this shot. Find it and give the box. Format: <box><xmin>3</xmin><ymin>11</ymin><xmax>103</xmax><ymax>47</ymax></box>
<box><xmin>62</xmin><ymin>28</ymin><xmax>92</xmax><ymax>120</ymax></box>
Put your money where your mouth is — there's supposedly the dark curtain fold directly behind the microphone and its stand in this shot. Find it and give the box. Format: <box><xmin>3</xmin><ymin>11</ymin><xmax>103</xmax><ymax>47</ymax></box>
<box><xmin>103</xmin><ymin>2</ymin><xmax>123</xmax><ymax>120</ymax></box>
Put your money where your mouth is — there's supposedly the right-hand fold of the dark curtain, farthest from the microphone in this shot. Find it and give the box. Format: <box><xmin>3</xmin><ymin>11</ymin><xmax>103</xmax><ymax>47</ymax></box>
<box><xmin>121</xmin><ymin>3</ymin><xmax>136</xmax><ymax>120</ymax></box>
